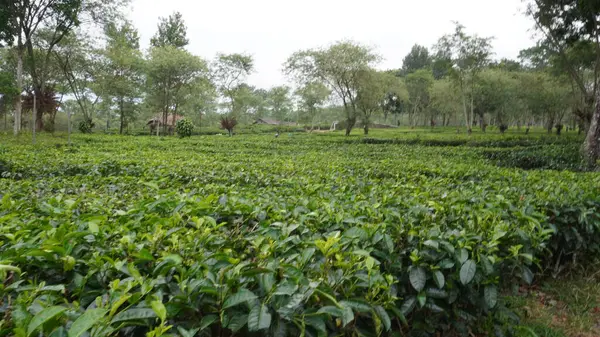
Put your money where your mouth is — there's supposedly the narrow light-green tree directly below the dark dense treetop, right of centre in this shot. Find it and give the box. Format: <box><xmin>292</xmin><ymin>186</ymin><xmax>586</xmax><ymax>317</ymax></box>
<box><xmin>405</xmin><ymin>69</ymin><xmax>433</xmax><ymax>128</ymax></box>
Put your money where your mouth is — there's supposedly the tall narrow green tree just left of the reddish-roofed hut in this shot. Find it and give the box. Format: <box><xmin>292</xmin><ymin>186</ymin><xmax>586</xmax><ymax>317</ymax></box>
<box><xmin>102</xmin><ymin>22</ymin><xmax>142</xmax><ymax>134</ymax></box>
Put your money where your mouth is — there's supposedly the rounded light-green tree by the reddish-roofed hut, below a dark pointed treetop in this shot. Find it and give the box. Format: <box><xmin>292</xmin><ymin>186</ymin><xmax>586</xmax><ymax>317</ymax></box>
<box><xmin>146</xmin><ymin>46</ymin><xmax>207</xmax><ymax>134</ymax></box>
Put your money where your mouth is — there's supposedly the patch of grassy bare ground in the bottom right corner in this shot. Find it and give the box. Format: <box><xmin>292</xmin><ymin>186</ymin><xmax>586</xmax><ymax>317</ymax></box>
<box><xmin>508</xmin><ymin>265</ymin><xmax>600</xmax><ymax>337</ymax></box>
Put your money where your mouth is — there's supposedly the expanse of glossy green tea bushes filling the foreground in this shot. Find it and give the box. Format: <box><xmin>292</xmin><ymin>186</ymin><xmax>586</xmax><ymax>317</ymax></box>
<box><xmin>0</xmin><ymin>130</ymin><xmax>600</xmax><ymax>337</ymax></box>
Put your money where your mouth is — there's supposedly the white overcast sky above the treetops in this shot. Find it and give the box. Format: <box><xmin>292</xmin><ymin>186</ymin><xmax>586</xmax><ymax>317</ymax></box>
<box><xmin>129</xmin><ymin>0</ymin><xmax>533</xmax><ymax>88</ymax></box>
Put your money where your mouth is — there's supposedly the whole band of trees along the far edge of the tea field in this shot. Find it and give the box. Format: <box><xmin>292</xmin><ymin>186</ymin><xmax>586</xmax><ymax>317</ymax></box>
<box><xmin>0</xmin><ymin>0</ymin><xmax>600</xmax><ymax>164</ymax></box>
